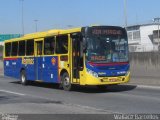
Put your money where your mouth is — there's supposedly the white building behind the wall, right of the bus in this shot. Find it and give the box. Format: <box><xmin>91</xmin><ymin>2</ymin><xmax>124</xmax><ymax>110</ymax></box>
<box><xmin>127</xmin><ymin>23</ymin><xmax>160</xmax><ymax>52</ymax></box>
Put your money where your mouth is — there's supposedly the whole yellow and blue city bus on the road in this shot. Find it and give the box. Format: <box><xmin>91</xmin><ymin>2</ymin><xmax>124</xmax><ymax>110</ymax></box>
<box><xmin>3</xmin><ymin>26</ymin><xmax>130</xmax><ymax>90</ymax></box>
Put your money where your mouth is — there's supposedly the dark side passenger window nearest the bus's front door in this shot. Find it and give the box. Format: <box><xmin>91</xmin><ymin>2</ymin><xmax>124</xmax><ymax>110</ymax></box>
<box><xmin>56</xmin><ymin>35</ymin><xmax>68</xmax><ymax>54</ymax></box>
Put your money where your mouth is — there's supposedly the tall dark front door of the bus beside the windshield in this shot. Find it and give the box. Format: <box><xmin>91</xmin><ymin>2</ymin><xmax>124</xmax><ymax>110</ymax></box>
<box><xmin>71</xmin><ymin>33</ymin><xmax>83</xmax><ymax>83</ymax></box>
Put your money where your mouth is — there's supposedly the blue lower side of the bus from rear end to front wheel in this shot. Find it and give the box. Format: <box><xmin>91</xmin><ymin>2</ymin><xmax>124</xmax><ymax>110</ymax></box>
<box><xmin>4</xmin><ymin>56</ymin><xmax>59</xmax><ymax>83</ymax></box>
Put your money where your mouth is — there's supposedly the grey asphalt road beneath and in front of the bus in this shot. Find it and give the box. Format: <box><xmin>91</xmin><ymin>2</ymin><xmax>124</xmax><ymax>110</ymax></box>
<box><xmin>0</xmin><ymin>76</ymin><xmax>160</xmax><ymax>114</ymax></box>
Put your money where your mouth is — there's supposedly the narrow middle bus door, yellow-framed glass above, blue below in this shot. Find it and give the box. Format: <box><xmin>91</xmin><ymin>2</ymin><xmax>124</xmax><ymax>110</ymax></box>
<box><xmin>35</xmin><ymin>39</ymin><xmax>43</xmax><ymax>80</ymax></box>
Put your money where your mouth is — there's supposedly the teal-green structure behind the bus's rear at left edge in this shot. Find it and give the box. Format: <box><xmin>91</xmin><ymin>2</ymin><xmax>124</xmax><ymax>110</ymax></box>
<box><xmin>0</xmin><ymin>34</ymin><xmax>22</xmax><ymax>45</ymax></box>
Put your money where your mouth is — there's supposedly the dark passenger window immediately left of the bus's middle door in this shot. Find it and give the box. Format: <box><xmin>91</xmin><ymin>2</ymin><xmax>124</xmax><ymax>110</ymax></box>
<box><xmin>26</xmin><ymin>40</ymin><xmax>34</xmax><ymax>56</ymax></box>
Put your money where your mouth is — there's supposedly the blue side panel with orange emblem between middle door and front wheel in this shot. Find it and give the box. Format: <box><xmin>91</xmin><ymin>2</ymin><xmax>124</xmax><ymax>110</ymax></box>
<box><xmin>42</xmin><ymin>56</ymin><xmax>59</xmax><ymax>83</ymax></box>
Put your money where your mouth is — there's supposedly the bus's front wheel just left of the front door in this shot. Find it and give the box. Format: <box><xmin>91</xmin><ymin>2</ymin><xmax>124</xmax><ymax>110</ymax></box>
<box><xmin>61</xmin><ymin>72</ymin><xmax>72</xmax><ymax>91</ymax></box>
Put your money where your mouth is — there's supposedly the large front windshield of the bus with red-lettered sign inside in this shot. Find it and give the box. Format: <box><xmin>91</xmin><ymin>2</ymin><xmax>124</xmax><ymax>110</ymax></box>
<box><xmin>86</xmin><ymin>36</ymin><xmax>128</xmax><ymax>63</ymax></box>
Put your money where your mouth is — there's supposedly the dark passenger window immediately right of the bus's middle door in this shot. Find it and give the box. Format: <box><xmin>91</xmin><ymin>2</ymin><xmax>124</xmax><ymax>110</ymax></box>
<box><xmin>44</xmin><ymin>37</ymin><xmax>55</xmax><ymax>55</ymax></box>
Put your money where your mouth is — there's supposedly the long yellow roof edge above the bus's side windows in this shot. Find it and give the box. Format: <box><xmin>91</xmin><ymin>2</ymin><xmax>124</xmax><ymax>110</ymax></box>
<box><xmin>5</xmin><ymin>27</ymin><xmax>82</xmax><ymax>42</ymax></box>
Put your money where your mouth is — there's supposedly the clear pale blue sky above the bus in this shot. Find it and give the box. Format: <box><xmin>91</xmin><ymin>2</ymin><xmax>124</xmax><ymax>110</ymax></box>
<box><xmin>0</xmin><ymin>0</ymin><xmax>160</xmax><ymax>34</ymax></box>
